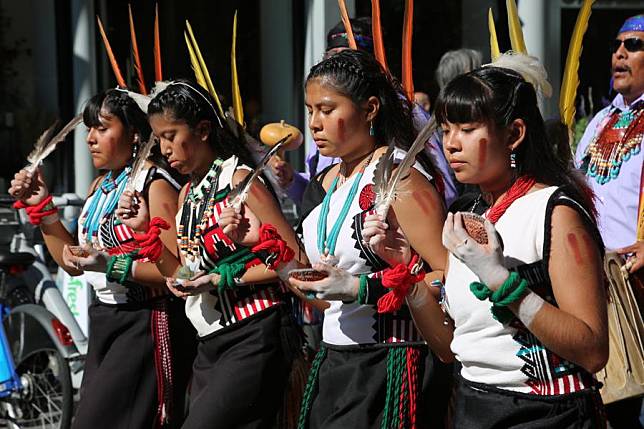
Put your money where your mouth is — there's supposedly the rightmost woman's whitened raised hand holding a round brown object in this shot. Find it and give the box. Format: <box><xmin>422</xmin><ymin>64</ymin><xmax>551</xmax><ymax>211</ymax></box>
<box><xmin>443</xmin><ymin>213</ymin><xmax>510</xmax><ymax>291</ymax></box>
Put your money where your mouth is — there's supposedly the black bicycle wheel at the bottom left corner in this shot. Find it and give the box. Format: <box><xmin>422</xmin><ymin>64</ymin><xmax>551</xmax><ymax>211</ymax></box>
<box><xmin>5</xmin><ymin>348</ymin><xmax>73</xmax><ymax>429</ymax></box>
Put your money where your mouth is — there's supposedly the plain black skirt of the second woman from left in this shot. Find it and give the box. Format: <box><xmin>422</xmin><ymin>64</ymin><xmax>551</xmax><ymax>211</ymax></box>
<box><xmin>183</xmin><ymin>305</ymin><xmax>295</xmax><ymax>429</ymax></box>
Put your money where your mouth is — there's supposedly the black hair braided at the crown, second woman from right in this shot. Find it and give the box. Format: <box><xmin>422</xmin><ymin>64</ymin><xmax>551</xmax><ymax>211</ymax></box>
<box><xmin>305</xmin><ymin>49</ymin><xmax>438</xmax><ymax>182</ymax></box>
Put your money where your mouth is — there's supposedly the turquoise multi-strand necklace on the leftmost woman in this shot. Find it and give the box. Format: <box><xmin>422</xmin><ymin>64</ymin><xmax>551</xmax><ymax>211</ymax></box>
<box><xmin>80</xmin><ymin>165</ymin><xmax>132</xmax><ymax>247</ymax></box>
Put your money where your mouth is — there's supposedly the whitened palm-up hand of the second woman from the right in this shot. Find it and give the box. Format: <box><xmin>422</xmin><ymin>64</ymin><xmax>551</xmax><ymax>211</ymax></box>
<box><xmin>288</xmin><ymin>264</ymin><xmax>360</xmax><ymax>301</ymax></box>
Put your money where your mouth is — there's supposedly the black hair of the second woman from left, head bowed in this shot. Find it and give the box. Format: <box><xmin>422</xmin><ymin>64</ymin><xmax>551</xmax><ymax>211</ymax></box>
<box><xmin>148</xmin><ymin>79</ymin><xmax>255</xmax><ymax>167</ymax></box>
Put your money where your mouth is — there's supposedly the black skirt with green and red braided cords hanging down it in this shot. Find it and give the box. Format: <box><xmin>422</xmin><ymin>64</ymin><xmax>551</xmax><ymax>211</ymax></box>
<box><xmin>300</xmin><ymin>344</ymin><xmax>452</xmax><ymax>429</ymax></box>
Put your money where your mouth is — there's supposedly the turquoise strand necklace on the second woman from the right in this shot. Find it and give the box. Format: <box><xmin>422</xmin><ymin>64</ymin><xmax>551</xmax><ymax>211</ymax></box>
<box><xmin>317</xmin><ymin>152</ymin><xmax>373</xmax><ymax>265</ymax></box>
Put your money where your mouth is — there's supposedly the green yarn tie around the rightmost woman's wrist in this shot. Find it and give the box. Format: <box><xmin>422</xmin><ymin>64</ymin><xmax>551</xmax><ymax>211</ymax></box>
<box><xmin>470</xmin><ymin>271</ymin><xmax>528</xmax><ymax>324</ymax></box>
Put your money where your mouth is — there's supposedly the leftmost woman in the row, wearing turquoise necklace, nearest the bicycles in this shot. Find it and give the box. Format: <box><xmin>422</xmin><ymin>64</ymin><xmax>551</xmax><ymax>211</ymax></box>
<box><xmin>10</xmin><ymin>89</ymin><xmax>195</xmax><ymax>429</ymax></box>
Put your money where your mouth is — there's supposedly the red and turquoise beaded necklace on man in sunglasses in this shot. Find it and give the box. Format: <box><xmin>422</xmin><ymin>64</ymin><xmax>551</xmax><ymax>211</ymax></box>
<box><xmin>586</xmin><ymin>102</ymin><xmax>644</xmax><ymax>185</ymax></box>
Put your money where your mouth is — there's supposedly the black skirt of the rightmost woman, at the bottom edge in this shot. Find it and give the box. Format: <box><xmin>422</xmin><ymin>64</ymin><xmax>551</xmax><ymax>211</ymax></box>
<box><xmin>454</xmin><ymin>376</ymin><xmax>606</xmax><ymax>429</ymax></box>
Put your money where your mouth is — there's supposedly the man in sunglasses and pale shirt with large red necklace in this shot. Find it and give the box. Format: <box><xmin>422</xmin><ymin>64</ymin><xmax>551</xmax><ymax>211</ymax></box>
<box><xmin>575</xmin><ymin>15</ymin><xmax>644</xmax><ymax>429</ymax></box>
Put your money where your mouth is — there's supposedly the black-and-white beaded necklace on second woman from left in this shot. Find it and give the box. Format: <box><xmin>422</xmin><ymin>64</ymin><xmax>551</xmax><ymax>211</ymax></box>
<box><xmin>177</xmin><ymin>158</ymin><xmax>223</xmax><ymax>261</ymax></box>
